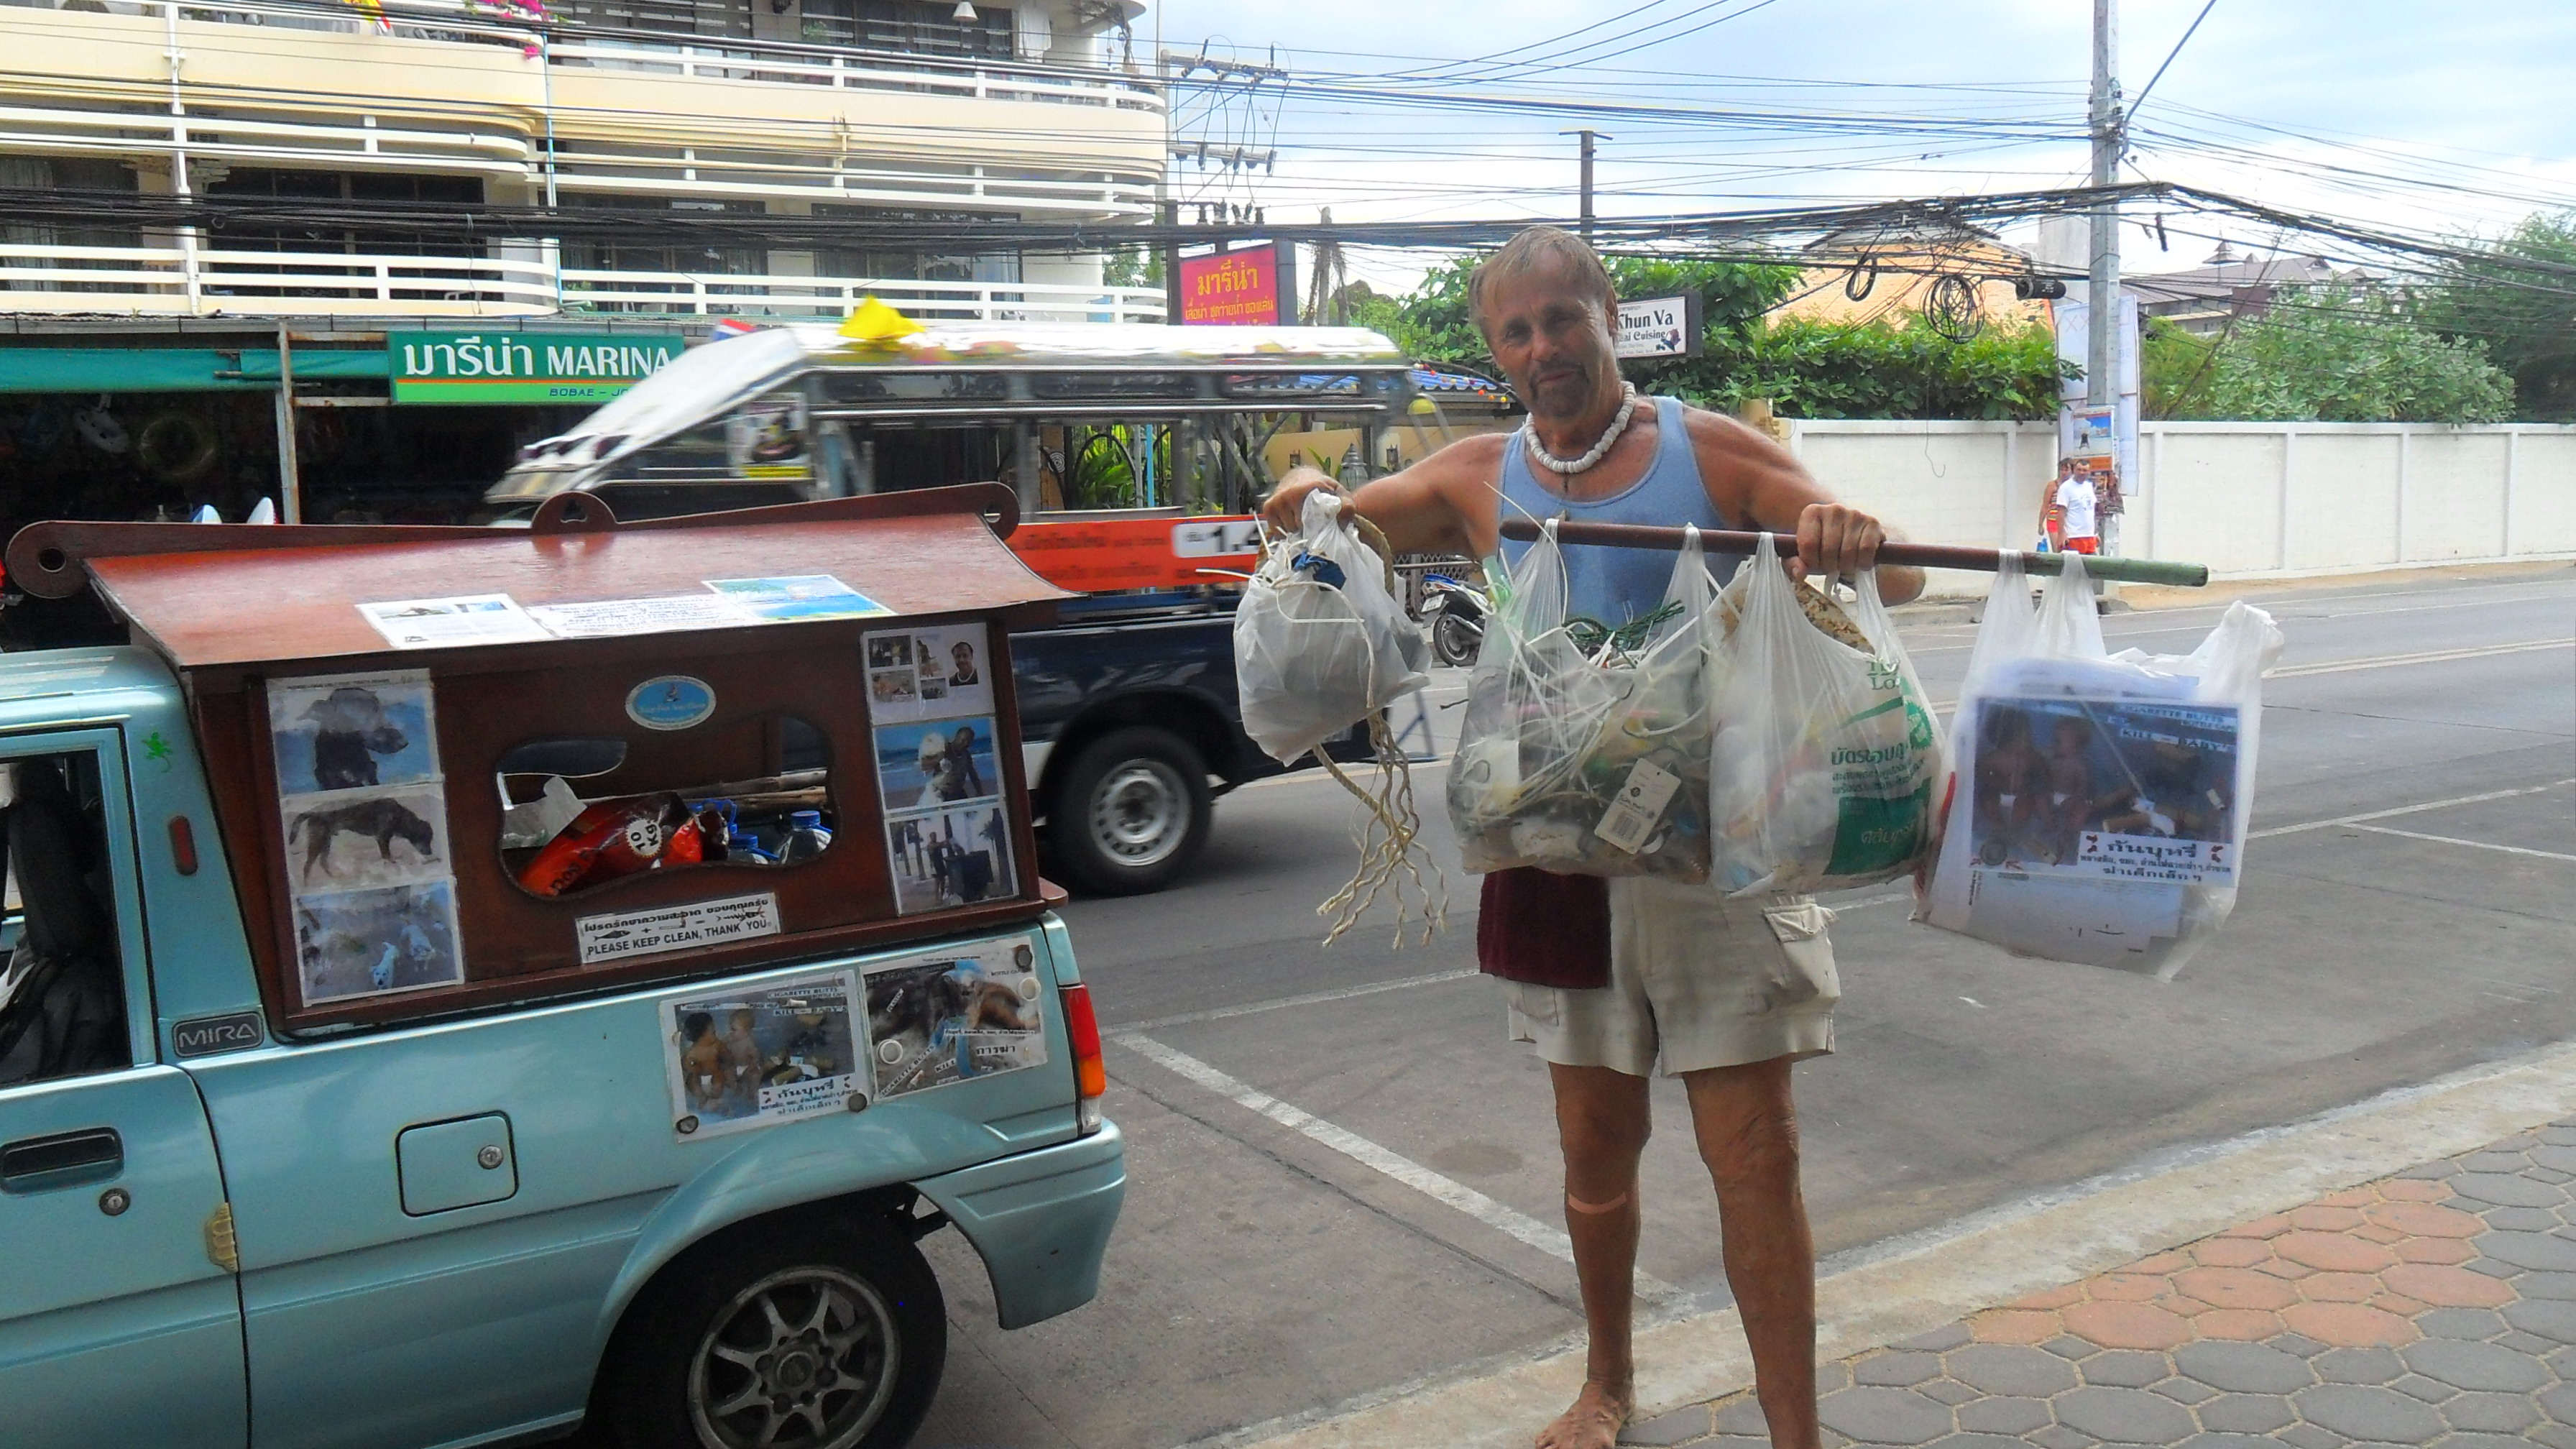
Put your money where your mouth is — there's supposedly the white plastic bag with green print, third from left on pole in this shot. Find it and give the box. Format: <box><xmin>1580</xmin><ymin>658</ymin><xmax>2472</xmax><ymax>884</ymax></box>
<box><xmin>1708</xmin><ymin>534</ymin><xmax>1945</xmax><ymax>895</ymax></box>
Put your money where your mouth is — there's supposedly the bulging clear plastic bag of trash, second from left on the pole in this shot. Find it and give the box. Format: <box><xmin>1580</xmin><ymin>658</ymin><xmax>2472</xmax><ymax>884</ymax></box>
<box><xmin>1448</xmin><ymin>526</ymin><xmax>1716</xmax><ymax>882</ymax></box>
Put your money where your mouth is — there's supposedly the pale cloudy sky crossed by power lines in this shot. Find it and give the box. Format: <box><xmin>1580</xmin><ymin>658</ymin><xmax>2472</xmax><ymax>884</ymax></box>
<box><xmin>1136</xmin><ymin>0</ymin><xmax>2576</xmax><ymax>284</ymax></box>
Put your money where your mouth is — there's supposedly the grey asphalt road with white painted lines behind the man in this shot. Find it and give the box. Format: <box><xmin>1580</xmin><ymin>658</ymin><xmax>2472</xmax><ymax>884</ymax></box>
<box><xmin>919</xmin><ymin>567</ymin><xmax>2576</xmax><ymax>1449</ymax></box>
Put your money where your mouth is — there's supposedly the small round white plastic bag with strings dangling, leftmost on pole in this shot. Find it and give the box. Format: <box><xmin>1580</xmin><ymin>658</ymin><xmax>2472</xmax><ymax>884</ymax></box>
<box><xmin>1234</xmin><ymin>487</ymin><xmax>1427</xmax><ymax>765</ymax></box>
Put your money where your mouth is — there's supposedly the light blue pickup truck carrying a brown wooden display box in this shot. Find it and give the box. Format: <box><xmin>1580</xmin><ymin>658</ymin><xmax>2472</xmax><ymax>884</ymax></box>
<box><xmin>0</xmin><ymin>490</ymin><xmax>1126</xmax><ymax>1449</ymax></box>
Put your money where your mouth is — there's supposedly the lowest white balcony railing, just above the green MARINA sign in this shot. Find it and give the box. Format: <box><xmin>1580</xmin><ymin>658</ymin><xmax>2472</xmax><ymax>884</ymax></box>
<box><xmin>0</xmin><ymin>242</ymin><xmax>1162</xmax><ymax>322</ymax></box>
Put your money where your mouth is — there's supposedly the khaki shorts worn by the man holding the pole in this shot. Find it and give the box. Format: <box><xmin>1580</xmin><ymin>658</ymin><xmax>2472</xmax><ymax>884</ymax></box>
<box><xmin>1501</xmin><ymin>877</ymin><xmax>1842</xmax><ymax>1077</ymax></box>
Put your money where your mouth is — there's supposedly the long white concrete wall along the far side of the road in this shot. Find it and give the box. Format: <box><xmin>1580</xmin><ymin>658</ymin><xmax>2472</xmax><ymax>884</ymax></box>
<box><xmin>1790</xmin><ymin>420</ymin><xmax>2576</xmax><ymax>596</ymax></box>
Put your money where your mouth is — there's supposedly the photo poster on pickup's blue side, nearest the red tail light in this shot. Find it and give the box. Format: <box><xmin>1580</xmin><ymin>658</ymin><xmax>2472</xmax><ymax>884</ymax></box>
<box><xmin>868</xmin><ymin>939</ymin><xmax>1046</xmax><ymax>1098</ymax></box>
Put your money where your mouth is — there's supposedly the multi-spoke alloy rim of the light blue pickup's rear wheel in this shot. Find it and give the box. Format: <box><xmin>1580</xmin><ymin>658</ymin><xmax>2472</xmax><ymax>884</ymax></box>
<box><xmin>688</xmin><ymin>1264</ymin><xmax>901</xmax><ymax>1449</ymax></box>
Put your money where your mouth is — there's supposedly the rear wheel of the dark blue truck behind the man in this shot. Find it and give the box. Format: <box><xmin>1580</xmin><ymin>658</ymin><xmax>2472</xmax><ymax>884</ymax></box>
<box><xmin>1046</xmin><ymin>724</ymin><xmax>1213</xmax><ymax>895</ymax></box>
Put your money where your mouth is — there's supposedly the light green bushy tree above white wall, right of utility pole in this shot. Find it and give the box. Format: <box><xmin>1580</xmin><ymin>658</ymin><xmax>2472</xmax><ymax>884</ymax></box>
<box><xmin>2145</xmin><ymin>281</ymin><xmax>2514</xmax><ymax>423</ymax></box>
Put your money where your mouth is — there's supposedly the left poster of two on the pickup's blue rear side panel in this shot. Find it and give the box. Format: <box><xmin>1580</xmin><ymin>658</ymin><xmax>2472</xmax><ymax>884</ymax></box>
<box><xmin>662</xmin><ymin>970</ymin><xmax>868</xmax><ymax>1137</ymax></box>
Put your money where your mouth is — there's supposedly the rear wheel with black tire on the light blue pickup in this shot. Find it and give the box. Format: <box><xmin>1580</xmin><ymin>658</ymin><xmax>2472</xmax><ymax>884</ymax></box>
<box><xmin>597</xmin><ymin>1220</ymin><xmax>948</xmax><ymax>1449</ymax></box>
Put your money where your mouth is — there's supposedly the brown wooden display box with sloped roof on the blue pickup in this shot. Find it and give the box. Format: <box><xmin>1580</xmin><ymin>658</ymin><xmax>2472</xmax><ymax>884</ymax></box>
<box><xmin>10</xmin><ymin>484</ymin><xmax>1062</xmax><ymax>1031</ymax></box>
